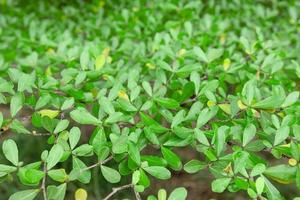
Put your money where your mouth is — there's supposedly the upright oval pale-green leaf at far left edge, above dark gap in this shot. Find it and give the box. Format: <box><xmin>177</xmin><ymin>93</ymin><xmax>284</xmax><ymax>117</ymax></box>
<box><xmin>2</xmin><ymin>139</ymin><xmax>19</xmax><ymax>166</ymax></box>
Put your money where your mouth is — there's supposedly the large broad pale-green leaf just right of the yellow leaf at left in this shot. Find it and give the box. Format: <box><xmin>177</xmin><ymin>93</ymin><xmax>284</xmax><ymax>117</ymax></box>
<box><xmin>70</xmin><ymin>107</ymin><xmax>101</xmax><ymax>125</ymax></box>
